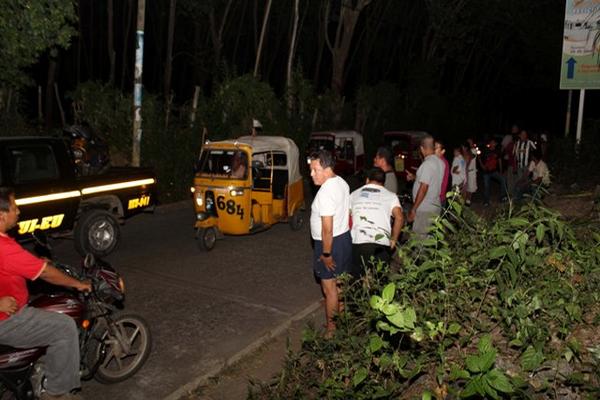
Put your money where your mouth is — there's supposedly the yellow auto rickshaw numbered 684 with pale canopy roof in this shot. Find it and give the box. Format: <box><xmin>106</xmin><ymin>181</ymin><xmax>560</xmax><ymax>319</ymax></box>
<box><xmin>192</xmin><ymin>136</ymin><xmax>304</xmax><ymax>251</ymax></box>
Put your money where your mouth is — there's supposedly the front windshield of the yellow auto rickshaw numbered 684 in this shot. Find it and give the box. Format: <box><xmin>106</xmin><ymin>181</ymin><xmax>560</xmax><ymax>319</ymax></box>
<box><xmin>195</xmin><ymin>149</ymin><xmax>248</xmax><ymax>179</ymax></box>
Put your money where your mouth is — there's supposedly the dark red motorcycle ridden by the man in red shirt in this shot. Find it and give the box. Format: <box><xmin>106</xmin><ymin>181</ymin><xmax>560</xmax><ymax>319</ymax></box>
<box><xmin>0</xmin><ymin>254</ymin><xmax>152</xmax><ymax>400</ymax></box>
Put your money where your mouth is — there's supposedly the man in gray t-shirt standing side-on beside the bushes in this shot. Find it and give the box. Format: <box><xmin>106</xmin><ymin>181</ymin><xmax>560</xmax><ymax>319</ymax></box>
<box><xmin>408</xmin><ymin>135</ymin><xmax>444</xmax><ymax>238</ymax></box>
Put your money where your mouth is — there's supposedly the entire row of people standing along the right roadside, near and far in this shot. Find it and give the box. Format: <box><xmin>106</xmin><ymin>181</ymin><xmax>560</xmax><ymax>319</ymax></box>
<box><xmin>310</xmin><ymin>126</ymin><xmax>550</xmax><ymax>335</ymax></box>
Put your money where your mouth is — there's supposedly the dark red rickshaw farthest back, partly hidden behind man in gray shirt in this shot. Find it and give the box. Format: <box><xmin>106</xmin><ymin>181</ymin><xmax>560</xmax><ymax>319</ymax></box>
<box><xmin>383</xmin><ymin>131</ymin><xmax>428</xmax><ymax>182</ymax></box>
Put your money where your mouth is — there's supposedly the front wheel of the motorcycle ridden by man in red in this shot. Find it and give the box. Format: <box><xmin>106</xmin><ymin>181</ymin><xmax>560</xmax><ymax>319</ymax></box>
<box><xmin>94</xmin><ymin>314</ymin><xmax>152</xmax><ymax>383</ymax></box>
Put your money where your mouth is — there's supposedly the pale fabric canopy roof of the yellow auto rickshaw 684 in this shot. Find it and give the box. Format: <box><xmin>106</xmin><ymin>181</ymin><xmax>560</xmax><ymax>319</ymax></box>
<box><xmin>208</xmin><ymin>136</ymin><xmax>302</xmax><ymax>183</ymax></box>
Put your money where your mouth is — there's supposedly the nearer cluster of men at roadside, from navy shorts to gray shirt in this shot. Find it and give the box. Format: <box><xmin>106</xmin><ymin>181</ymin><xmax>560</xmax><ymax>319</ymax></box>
<box><xmin>310</xmin><ymin>136</ymin><xmax>449</xmax><ymax>335</ymax></box>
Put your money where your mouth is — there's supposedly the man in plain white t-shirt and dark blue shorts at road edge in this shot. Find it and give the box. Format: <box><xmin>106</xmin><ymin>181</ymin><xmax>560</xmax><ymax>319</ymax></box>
<box><xmin>310</xmin><ymin>150</ymin><xmax>352</xmax><ymax>336</ymax></box>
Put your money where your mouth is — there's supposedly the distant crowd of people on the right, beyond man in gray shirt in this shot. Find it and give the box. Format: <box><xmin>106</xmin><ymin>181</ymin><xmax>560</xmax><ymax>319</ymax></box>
<box><xmin>451</xmin><ymin>125</ymin><xmax>550</xmax><ymax>206</ymax></box>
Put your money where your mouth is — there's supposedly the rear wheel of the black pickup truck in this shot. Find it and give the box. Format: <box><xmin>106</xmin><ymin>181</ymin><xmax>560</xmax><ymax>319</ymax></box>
<box><xmin>73</xmin><ymin>210</ymin><xmax>121</xmax><ymax>257</ymax></box>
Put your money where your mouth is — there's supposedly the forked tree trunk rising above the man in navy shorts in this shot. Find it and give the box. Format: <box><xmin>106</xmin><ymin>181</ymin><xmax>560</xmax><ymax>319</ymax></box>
<box><xmin>326</xmin><ymin>0</ymin><xmax>371</xmax><ymax>96</ymax></box>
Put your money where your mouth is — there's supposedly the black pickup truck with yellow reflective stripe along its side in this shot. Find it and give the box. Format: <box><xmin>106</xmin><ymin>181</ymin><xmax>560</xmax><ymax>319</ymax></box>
<box><xmin>0</xmin><ymin>137</ymin><xmax>156</xmax><ymax>256</ymax></box>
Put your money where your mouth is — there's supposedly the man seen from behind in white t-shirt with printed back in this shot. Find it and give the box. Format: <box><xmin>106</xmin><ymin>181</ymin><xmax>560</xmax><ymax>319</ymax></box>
<box><xmin>350</xmin><ymin>168</ymin><xmax>404</xmax><ymax>275</ymax></box>
